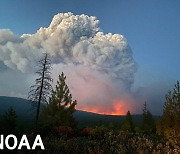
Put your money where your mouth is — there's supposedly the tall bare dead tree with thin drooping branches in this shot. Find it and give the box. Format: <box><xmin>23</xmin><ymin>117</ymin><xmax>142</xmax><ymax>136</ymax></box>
<box><xmin>28</xmin><ymin>53</ymin><xmax>52</xmax><ymax>128</ymax></box>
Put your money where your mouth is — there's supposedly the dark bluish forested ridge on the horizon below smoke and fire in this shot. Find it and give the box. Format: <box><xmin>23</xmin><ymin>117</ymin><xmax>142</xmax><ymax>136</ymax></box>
<box><xmin>0</xmin><ymin>96</ymin><xmax>158</xmax><ymax>127</ymax></box>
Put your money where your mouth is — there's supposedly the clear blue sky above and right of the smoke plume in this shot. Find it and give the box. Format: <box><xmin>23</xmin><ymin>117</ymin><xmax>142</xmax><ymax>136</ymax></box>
<box><xmin>0</xmin><ymin>0</ymin><xmax>180</xmax><ymax>113</ymax></box>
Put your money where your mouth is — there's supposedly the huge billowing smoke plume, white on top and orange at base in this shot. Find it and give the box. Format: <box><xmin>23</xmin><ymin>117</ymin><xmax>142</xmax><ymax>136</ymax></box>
<box><xmin>0</xmin><ymin>13</ymin><xmax>136</xmax><ymax>114</ymax></box>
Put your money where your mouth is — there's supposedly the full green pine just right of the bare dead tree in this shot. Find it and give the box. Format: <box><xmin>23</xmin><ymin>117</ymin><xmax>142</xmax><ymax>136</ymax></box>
<box><xmin>41</xmin><ymin>73</ymin><xmax>77</xmax><ymax>127</ymax></box>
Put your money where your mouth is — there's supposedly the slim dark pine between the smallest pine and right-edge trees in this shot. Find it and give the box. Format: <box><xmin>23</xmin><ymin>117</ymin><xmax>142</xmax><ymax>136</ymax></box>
<box><xmin>141</xmin><ymin>102</ymin><xmax>156</xmax><ymax>133</ymax></box>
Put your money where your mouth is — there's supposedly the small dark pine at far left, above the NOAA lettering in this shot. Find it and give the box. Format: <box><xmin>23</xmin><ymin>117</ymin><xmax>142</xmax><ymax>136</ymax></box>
<box><xmin>3</xmin><ymin>107</ymin><xmax>17</xmax><ymax>134</ymax></box>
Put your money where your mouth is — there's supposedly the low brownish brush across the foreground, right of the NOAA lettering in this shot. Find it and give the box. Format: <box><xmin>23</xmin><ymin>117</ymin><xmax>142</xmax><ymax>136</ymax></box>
<box><xmin>35</xmin><ymin>129</ymin><xmax>180</xmax><ymax>154</ymax></box>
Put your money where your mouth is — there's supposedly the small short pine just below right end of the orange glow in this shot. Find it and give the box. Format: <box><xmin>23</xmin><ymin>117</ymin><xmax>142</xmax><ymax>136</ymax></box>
<box><xmin>122</xmin><ymin>111</ymin><xmax>134</xmax><ymax>132</ymax></box>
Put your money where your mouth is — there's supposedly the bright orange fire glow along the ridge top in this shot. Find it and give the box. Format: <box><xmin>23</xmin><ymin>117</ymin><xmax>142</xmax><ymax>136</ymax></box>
<box><xmin>77</xmin><ymin>101</ymin><xmax>129</xmax><ymax>115</ymax></box>
